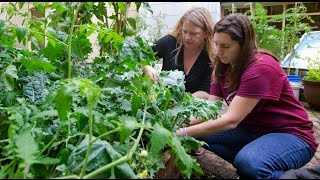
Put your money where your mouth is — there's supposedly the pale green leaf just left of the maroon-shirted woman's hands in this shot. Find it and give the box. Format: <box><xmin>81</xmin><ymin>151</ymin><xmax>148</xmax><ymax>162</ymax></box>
<box><xmin>150</xmin><ymin>124</ymin><xmax>171</xmax><ymax>155</ymax></box>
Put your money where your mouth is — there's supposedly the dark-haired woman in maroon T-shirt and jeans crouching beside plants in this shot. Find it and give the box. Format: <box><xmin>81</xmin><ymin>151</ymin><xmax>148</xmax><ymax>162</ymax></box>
<box><xmin>176</xmin><ymin>13</ymin><xmax>318</xmax><ymax>179</ymax></box>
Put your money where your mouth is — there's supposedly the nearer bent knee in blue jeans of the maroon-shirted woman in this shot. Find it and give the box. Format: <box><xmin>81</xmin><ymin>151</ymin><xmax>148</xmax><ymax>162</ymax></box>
<box><xmin>234</xmin><ymin>133</ymin><xmax>314</xmax><ymax>179</ymax></box>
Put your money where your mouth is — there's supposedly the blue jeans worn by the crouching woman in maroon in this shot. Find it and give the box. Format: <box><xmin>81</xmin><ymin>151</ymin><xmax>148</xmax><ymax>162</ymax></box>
<box><xmin>199</xmin><ymin>124</ymin><xmax>315</xmax><ymax>179</ymax></box>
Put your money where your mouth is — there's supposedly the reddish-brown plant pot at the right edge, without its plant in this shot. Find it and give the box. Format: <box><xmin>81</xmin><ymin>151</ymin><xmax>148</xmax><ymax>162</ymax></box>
<box><xmin>302</xmin><ymin>80</ymin><xmax>320</xmax><ymax>110</ymax></box>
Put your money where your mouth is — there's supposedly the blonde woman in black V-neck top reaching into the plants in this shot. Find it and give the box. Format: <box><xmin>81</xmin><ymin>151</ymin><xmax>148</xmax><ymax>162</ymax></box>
<box><xmin>143</xmin><ymin>7</ymin><xmax>214</xmax><ymax>98</ymax></box>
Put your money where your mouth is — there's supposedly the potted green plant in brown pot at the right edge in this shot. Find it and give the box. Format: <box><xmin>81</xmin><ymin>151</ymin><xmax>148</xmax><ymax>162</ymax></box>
<box><xmin>302</xmin><ymin>51</ymin><xmax>320</xmax><ymax>110</ymax></box>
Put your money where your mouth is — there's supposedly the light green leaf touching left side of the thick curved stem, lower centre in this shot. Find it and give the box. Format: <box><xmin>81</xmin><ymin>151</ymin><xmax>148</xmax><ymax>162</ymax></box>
<box><xmin>119</xmin><ymin>116</ymin><xmax>137</xmax><ymax>143</ymax></box>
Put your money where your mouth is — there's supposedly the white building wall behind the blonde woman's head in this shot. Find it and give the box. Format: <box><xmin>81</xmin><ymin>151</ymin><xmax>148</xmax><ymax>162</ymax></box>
<box><xmin>139</xmin><ymin>2</ymin><xmax>221</xmax><ymax>39</ymax></box>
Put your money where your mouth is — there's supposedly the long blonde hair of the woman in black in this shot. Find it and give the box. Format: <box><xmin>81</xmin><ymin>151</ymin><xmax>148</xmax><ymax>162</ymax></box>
<box><xmin>169</xmin><ymin>7</ymin><xmax>215</xmax><ymax>62</ymax></box>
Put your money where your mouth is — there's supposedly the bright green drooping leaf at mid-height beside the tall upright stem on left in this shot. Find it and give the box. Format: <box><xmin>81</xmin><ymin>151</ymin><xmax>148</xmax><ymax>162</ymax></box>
<box><xmin>55</xmin><ymin>86</ymin><xmax>72</xmax><ymax>121</ymax></box>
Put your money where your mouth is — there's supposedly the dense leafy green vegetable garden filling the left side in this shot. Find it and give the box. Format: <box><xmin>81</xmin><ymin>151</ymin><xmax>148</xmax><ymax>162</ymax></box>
<box><xmin>0</xmin><ymin>2</ymin><xmax>222</xmax><ymax>179</ymax></box>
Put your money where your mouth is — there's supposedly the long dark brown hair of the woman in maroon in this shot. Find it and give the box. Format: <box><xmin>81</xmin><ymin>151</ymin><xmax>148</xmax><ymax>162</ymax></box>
<box><xmin>212</xmin><ymin>13</ymin><xmax>279</xmax><ymax>91</ymax></box>
